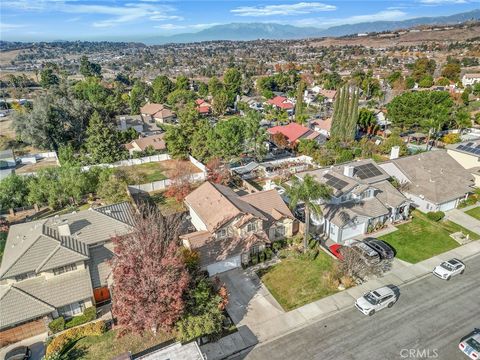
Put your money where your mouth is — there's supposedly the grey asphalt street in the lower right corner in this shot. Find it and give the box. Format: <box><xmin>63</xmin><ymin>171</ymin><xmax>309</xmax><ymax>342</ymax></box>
<box><xmin>246</xmin><ymin>256</ymin><xmax>480</xmax><ymax>360</ymax></box>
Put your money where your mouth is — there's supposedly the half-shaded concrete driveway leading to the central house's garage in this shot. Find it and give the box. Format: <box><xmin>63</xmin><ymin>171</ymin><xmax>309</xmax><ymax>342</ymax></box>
<box><xmin>217</xmin><ymin>269</ymin><xmax>284</xmax><ymax>328</ymax></box>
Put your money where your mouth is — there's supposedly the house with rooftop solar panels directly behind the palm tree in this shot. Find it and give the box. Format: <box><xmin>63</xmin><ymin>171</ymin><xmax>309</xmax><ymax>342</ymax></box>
<box><xmin>296</xmin><ymin>159</ymin><xmax>410</xmax><ymax>243</ymax></box>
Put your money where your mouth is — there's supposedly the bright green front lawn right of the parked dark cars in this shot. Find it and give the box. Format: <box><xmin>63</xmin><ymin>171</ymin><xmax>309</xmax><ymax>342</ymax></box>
<box><xmin>380</xmin><ymin>211</ymin><xmax>464</xmax><ymax>263</ymax></box>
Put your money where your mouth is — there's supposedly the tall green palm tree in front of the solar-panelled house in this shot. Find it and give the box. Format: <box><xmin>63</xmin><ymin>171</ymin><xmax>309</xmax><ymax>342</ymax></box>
<box><xmin>287</xmin><ymin>175</ymin><xmax>332</xmax><ymax>252</ymax></box>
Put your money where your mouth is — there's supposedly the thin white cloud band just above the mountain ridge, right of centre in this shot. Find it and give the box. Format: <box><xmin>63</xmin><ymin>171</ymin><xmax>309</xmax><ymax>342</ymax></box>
<box><xmin>295</xmin><ymin>10</ymin><xmax>407</xmax><ymax>28</ymax></box>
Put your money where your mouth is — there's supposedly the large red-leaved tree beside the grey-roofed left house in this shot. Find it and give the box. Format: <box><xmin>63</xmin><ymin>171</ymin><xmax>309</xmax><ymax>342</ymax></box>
<box><xmin>112</xmin><ymin>206</ymin><xmax>190</xmax><ymax>335</ymax></box>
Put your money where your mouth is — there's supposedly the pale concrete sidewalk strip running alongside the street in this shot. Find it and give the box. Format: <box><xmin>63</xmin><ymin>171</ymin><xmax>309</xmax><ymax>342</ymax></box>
<box><xmin>237</xmin><ymin>241</ymin><xmax>480</xmax><ymax>342</ymax></box>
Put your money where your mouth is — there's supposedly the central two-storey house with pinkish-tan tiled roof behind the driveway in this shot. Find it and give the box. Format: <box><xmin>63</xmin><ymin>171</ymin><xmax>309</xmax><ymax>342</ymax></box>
<box><xmin>181</xmin><ymin>182</ymin><xmax>296</xmax><ymax>275</ymax></box>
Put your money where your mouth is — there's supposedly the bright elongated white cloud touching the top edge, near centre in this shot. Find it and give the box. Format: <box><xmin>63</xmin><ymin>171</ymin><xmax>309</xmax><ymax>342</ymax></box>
<box><xmin>230</xmin><ymin>2</ymin><xmax>337</xmax><ymax>17</ymax></box>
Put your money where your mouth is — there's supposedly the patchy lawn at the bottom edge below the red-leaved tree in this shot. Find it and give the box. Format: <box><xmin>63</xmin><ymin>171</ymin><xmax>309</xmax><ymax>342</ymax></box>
<box><xmin>64</xmin><ymin>330</ymin><xmax>172</xmax><ymax>360</ymax></box>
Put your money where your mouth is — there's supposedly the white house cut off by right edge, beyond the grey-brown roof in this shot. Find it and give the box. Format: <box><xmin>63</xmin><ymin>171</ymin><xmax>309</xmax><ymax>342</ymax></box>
<box><xmin>446</xmin><ymin>140</ymin><xmax>480</xmax><ymax>187</ymax></box>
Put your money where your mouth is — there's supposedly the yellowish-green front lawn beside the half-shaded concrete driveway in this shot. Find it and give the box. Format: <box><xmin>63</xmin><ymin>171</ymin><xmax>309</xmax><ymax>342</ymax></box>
<box><xmin>259</xmin><ymin>251</ymin><xmax>338</xmax><ymax>311</ymax></box>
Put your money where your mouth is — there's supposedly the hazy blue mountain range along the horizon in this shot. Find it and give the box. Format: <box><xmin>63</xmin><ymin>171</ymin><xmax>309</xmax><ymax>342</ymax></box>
<box><xmin>146</xmin><ymin>9</ymin><xmax>480</xmax><ymax>45</ymax></box>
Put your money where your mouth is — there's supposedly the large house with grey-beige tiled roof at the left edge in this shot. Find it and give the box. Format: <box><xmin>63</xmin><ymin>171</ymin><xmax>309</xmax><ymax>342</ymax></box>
<box><xmin>0</xmin><ymin>202</ymin><xmax>133</xmax><ymax>346</ymax></box>
